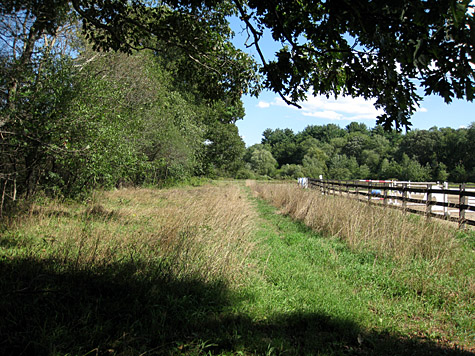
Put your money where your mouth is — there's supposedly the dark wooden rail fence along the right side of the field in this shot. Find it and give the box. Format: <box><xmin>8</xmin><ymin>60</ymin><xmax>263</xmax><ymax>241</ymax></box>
<box><xmin>308</xmin><ymin>179</ymin><xmax>475</xmax><ymax>228</ymax></box>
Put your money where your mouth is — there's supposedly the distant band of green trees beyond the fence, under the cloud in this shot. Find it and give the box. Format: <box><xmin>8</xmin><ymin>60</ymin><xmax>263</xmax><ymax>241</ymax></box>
<box><xmin>241</xmin><ymin>122</ymin><xmax>475</xmax><ymax>182</ymax></box>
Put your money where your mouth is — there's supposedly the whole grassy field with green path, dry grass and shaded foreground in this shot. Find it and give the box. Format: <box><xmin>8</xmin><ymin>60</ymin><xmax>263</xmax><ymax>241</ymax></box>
<box><xmin>0</xmin><ymin>183</ymin><xmax>475</xmax><ymax>355</ymax></box>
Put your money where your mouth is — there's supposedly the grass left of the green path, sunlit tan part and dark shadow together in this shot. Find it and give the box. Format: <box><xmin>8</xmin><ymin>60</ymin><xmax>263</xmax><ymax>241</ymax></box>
<box><xmin>0</xmin><ymin>186</ymin><xmax>255</xmax><ymax>355</ymax></box>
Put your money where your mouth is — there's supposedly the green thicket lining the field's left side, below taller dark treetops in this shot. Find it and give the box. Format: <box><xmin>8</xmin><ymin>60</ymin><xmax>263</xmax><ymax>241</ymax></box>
<box><xmin>1</xmin><ymin>44</ymin><xmax>244</xmax><ymax>204</ymax></box>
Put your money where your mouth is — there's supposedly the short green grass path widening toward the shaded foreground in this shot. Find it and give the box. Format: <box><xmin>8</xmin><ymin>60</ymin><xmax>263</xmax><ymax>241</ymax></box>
<box><xmin>224</xmin><ymin>188</ymin><xmax>475</xmax><ymax>355</ymax></box>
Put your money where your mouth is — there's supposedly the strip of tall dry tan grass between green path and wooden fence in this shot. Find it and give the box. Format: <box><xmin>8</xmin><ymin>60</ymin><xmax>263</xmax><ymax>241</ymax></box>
<box><xmin>252</xmin><ymin>184</ymin><xmax>459</xmax><ymax>261</ymax></box>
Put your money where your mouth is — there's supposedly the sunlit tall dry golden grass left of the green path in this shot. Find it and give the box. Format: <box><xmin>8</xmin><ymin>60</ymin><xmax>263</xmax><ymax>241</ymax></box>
<box><xmin>4</xmin><ymin>185</ymin><xmax>255</xmax><ymax>283</ymax></box>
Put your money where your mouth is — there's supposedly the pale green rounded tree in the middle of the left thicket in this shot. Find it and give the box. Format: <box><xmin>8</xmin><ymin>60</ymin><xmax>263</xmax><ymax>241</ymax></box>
<box><xmin>47</xmin><ymin>50</ymin><xmax>209</xmax><ymax>195</ymax></box>
